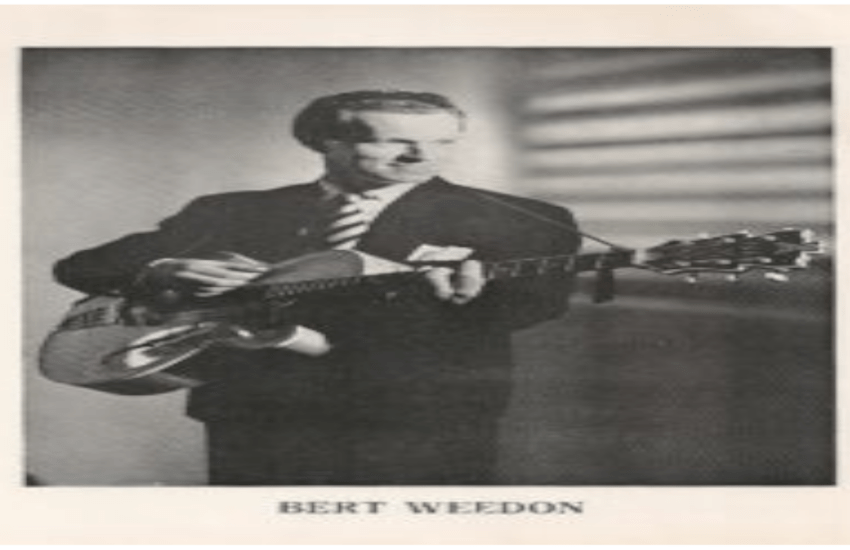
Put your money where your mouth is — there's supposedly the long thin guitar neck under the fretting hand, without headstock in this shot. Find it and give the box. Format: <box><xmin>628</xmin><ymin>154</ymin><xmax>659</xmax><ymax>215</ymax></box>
<box><xmin>255</xmin><ymin>250</ymin><xmax>634</xmax><ymax>299</ymax></box>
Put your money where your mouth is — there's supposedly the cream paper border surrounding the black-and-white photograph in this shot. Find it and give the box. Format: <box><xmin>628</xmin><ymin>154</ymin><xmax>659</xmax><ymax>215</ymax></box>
<box><xmin>0</xmin><ymin>6</ymin><xmax>850</xmax><ymax>544</ymax></box>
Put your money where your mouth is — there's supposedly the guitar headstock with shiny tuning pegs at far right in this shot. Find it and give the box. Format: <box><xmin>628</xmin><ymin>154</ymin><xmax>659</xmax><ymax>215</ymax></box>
<box><xmin>635</xmin><ymin>229</ymin><xmax>825</xmax><ymax>281</ymax></box>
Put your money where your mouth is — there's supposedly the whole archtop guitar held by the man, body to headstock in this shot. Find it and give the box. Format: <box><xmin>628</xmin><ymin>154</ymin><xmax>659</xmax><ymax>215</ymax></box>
<box><xmin>40</xmin><ymin>229</ymin><xmax>822</xmax><ymax>395</ymax></box>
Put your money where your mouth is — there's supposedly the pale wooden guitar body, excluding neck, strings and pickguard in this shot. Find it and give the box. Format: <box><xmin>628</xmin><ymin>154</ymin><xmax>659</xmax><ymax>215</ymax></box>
<box><xmin>40</xmin><ymin>250</ymin><xmax>372</xmax><ymax>395</ymax></box>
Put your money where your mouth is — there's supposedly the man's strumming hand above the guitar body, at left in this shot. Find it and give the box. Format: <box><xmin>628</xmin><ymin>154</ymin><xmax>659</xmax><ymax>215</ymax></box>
<box><xmin>144</xmin><ymin>256</ymin><xmax>268</xmax><ymax>298</ymax></box>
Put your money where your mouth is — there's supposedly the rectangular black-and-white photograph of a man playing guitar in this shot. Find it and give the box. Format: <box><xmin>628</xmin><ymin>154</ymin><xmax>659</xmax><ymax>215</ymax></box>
<box><xmin>20</xmin><ymin>43</ymin><xmax>836</xmax><ymax>490</ymax></box>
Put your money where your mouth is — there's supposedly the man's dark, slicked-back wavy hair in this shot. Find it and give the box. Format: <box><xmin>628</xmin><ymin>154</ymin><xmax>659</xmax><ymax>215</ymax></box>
<box><xmin>292</xmin><ymin>90</ymin><xmax>466</xmax><ymax>153</ymax></box>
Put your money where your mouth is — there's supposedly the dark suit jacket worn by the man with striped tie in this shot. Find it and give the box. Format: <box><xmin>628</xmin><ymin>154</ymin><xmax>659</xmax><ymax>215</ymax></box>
<box><xmin>55</xmin><ymin>178</ymin><xmax>579</xmax><ymax>424</ymax></box>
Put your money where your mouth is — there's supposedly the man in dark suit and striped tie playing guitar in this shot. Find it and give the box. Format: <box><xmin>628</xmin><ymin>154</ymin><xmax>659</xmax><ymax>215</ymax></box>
<box><xmin>56</xmin><ymin>91</ymin><xmax>579</xmax><ymax>485</ymax></box>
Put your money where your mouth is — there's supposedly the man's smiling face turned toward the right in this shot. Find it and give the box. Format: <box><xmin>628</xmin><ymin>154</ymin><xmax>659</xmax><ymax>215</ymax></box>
<box><xmin>325</xmin><ymin>111</ymin><xmax>461</xmax><ymax>190</ymax></box>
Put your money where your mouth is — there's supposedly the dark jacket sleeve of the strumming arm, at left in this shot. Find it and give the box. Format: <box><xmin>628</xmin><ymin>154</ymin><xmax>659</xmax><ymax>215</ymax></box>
<box><xmin>53</xmin><ymin>197</ymin><xmax>224</xmax><ymax>294</ymax></box>
